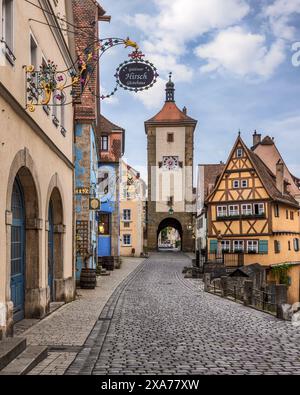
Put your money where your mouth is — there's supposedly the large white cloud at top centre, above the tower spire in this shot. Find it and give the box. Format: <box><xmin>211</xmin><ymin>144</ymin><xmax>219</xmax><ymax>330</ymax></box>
<box><xmin>125</xmin><ymin>0</ymin><xmax>250</xmax><ymax>81</ymax></box>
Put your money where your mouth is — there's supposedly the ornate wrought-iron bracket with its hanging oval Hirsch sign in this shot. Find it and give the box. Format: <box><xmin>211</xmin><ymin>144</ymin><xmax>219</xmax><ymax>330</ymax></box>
<box><xmin>24</xmin><ymin>38</ymin><xmax>158</xmax><ymax>112</ymax></box>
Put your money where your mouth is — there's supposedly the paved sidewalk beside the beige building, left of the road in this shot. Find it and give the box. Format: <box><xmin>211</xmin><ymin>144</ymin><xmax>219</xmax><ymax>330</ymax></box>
<box><xmin>20</xmin><ymin>258</ymin><xmax>144</xmax><ymax>375</ymax></box>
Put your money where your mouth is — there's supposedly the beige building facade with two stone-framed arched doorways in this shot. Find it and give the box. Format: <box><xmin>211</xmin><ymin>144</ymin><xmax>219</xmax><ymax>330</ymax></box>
<box><xmin>0</xmin><ymin>0</ymin><xmax>75</xmax><ymax>337</ymax></box>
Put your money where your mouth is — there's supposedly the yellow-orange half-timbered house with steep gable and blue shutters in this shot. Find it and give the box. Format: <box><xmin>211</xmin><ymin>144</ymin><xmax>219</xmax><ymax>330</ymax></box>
<box><xmin>206</xmin><ymin>135</ymin><xmax>300</xmax><ymax>303</ymax></box>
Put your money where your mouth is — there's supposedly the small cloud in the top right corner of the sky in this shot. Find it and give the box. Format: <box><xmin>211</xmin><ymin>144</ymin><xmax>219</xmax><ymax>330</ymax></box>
<box><xmin>263</xmin><ymin>0</ymin><xmax>300</xmax><ymax>41</ymax></box>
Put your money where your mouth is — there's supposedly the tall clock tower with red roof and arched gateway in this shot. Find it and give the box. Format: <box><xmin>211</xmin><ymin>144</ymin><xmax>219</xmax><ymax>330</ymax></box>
<box><xmin>145</xmin><ymin>73</ymin><xmax>197</xmax><ymax>252</ymax></box>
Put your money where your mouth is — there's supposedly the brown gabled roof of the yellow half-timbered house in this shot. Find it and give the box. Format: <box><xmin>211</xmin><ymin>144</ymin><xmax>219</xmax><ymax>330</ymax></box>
<box><xmin>207</xmin><ymin>136</ymin><xmax>299</xmax><ymax>208</ymax></box>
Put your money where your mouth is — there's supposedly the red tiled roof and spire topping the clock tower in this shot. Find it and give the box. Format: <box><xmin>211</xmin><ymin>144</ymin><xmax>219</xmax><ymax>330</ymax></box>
<box><xmin>145</xmin><ymin>73</ymin><xmax>197</xmax><ymax>125</ymax></box>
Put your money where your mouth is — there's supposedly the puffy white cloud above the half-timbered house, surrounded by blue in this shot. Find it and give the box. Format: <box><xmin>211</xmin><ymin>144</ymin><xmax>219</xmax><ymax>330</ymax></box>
<box><xmin>195</xmin><ymin>27</ymin><xmax>285</xmax><ymax>78</ymax></box>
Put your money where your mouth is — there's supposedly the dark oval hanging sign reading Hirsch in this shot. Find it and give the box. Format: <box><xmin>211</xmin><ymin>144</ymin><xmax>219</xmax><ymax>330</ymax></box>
<box><xmin>115</xmin><ymin>59</ymin><xmax>159</xmax><ymax>92</ymax></box>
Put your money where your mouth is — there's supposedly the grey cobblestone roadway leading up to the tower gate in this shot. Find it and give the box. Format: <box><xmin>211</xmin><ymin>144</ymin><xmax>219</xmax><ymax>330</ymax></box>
<box><xmin>67</xmin><ymin>253</ymin><xmax>300</xmax><ymax>375</ymax></box>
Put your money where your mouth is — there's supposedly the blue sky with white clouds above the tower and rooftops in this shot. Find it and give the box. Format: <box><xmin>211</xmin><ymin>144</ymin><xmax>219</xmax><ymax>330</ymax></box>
<box><xmin>100</xmin><ymin>0</ymin><xmax>300</xmax><ymax>183</ymax></box>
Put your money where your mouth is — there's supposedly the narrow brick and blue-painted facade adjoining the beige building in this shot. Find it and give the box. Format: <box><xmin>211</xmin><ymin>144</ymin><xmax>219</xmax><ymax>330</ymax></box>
<box><xmin>72</xmin><ymin>0</ymin><xmax>109</xmax><ymax>281</ymax></box>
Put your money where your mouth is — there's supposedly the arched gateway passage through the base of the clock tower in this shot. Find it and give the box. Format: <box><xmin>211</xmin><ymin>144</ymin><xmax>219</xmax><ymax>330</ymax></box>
<box><xmin>157</xmin><ymin>218</ymin><xmax>183</xmax><ymax>251</ymax></box>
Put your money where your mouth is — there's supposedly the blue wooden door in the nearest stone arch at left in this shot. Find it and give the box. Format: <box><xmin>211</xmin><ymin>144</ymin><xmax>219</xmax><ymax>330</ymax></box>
<box><xmin>11</xmin><ymin>179</ymin><xmax>25</xmax><ymax>322</ymax></box>
